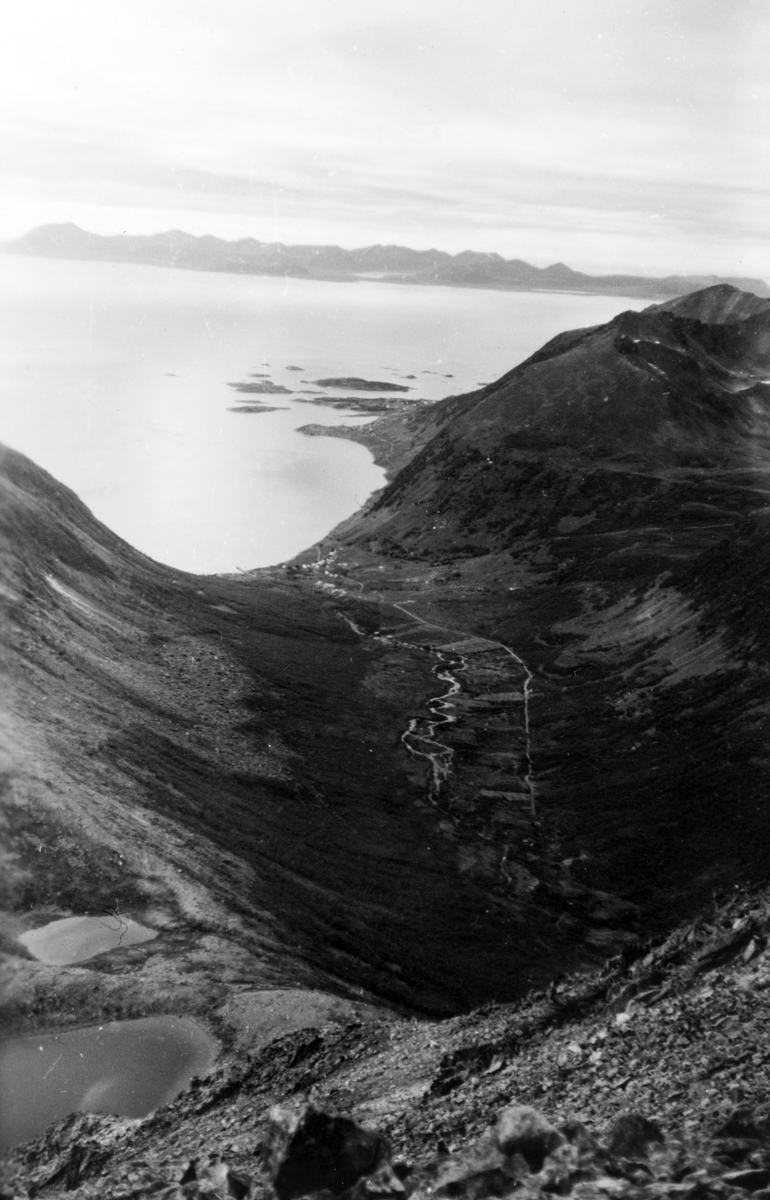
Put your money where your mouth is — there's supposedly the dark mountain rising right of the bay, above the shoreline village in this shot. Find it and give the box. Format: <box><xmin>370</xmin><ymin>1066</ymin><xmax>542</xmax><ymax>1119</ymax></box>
<box><xmin>338</xmin><ymin>288</ymin><xmax>770</xmax><ymax>557</ymax></box>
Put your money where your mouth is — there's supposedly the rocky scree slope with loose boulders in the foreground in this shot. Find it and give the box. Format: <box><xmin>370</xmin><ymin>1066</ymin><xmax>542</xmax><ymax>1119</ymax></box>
<box><xmin>2</xmin><ymin>889</ymin><xmax>770</xmax><ymax>1200</ymax></box>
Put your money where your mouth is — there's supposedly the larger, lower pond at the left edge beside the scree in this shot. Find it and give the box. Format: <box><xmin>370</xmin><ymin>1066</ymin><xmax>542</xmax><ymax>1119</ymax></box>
<box><xmin>0</xmin><ymin>1016</ymin><xmax>218</xmax><ymax>1150</ymax></box>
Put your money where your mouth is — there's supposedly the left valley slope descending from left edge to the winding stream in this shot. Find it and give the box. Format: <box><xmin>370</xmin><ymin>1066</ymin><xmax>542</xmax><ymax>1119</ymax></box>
<box><xmin>0</xmin><ymin>441</ymin><xmax>628</xmax><ymax>1021</ymax></box>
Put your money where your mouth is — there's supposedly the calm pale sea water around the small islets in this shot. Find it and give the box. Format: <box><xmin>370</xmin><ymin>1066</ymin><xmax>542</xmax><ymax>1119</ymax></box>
<box><xmin>0</xmin><ymin>254</ymin><xmax>643</xmax><ymax>574</ymax></box>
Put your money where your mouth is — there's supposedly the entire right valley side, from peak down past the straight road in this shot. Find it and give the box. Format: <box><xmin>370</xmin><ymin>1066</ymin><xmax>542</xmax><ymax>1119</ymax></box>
<box><xmin>305</xmin><ymin>288</ymin><xmax>770</xmax><ymax>920</ymax></box>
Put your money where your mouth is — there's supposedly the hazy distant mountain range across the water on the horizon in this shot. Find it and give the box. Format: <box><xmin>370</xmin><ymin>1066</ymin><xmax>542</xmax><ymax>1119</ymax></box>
<box><xmin>5</xmin><ymin>224</ymin><xmax>770</xmax><ymax>300</ymax></box>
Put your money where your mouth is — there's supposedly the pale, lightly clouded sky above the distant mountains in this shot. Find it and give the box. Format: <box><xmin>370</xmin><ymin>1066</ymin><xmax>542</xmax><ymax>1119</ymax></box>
<box><xmin>0</xmin><ymin>0</ymin><xmax>770</xmax><ymax>280</ymax></box>
